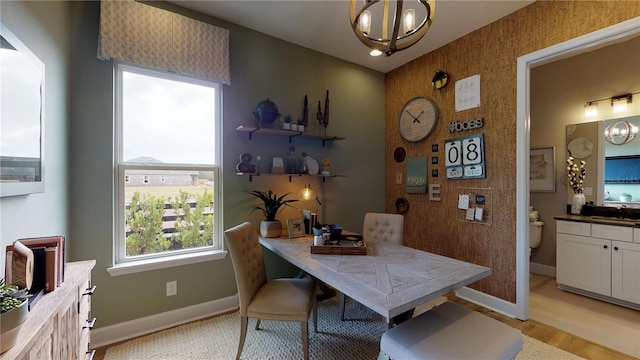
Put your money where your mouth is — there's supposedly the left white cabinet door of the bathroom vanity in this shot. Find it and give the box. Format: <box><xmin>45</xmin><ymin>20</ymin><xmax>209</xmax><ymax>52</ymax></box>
<box><xmin>556</xmin><ymin>233</ymin><xmax>611</xmax><ymax>296</ymax></box>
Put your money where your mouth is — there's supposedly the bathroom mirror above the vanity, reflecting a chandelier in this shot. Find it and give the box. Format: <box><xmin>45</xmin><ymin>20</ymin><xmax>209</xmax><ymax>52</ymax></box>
<box><xmin>567</xmin><ymin>115</ymin><xmax>640</xmax><ymax>208</ymax></box>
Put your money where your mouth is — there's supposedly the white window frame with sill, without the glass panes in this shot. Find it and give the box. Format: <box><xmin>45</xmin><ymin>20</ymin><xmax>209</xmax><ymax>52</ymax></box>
<box><xmin>107</xmin><ymin>61</ymin><xmax>226</xmax><ymax>276</ymax></box>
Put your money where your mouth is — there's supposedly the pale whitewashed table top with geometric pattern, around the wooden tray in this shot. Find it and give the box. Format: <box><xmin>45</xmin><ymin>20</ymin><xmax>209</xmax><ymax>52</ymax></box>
<box><xmin>260</xmin><ymin>236</ymin><xmax>491</xmax><ymax>322</ymax></box>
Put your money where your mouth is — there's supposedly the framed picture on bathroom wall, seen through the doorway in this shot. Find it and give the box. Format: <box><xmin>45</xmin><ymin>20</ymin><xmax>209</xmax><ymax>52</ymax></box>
<box><xmin>529</xmin><ymin>147</ymin><xmax>556</xmax><ymax>192</ymax></box>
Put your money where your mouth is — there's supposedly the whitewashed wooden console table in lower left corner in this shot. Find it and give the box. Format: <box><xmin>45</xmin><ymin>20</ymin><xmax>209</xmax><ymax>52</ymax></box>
<box><xmin>0</xmin><ymin>260</ymin><xmax>96</xmax><ymax>360</ymax></box>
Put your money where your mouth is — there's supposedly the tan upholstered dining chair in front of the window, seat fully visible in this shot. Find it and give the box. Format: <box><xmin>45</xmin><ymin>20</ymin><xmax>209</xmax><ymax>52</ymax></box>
<box><xmin>224</xmin><ymin>222</ymin><xmax>318</xmax><ymax>360</ymax></box>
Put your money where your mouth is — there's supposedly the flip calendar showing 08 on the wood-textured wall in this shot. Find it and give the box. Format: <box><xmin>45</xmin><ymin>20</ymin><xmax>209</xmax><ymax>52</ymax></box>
<box><xmin>444</xmin><ymin>134</ymin><xmax>486</xmax><ymax>179</ymax></box>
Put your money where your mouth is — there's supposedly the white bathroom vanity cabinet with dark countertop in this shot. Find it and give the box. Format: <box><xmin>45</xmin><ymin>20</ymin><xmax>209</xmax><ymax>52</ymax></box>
<box><xmin>555</xmin><ymin>215</ymin><xmax>640</xmax><ymax>310</ymax></box>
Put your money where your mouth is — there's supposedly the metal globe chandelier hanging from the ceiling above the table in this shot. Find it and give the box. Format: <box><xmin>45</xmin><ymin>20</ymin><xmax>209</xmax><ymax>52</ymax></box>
<box><xmin>349</xmin><ymin>0</ymin><xmax>436</xmax><ymax>56</ymax></box>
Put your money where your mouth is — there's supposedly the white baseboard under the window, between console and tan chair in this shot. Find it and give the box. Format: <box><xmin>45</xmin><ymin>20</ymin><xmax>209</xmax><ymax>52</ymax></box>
<box><xmin>91</xmin><ymin>295</ymin><xmax>239</xmax><ymax>349</ymax></box>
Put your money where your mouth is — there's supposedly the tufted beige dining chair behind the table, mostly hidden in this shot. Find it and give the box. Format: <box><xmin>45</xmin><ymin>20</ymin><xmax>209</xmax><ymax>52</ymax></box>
<box><xmin>340</xmin><ymin>213</ymin><xmax>404</xmax><ymax>321</ymax></box>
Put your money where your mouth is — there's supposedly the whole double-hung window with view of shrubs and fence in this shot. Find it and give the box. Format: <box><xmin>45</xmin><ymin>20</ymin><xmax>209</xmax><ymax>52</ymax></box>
<box><xmin>115</xmin><ymin>63</ymin><xmax>222</xmax><ymax>264</ymax></box>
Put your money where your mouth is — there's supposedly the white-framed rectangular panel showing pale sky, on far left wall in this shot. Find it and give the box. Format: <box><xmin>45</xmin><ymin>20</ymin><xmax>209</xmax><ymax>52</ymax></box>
<box><xmin>0</xmin><ymin>23</ymin><xmax>44</xmax><ymax>197</ymax></box>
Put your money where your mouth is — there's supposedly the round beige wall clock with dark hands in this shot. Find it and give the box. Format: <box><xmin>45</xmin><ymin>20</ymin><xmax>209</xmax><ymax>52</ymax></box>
<box><xmin>398</xmin><ymin>96</ymin><xmax>438</xmax><ymax>141</ymax></box>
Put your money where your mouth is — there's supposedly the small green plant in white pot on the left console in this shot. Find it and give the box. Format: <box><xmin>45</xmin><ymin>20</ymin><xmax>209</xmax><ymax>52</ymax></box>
<box><xmin>0</xmin><ymin>278</ymin><xmax>30</xmax><ymax>353</ymax></box>
